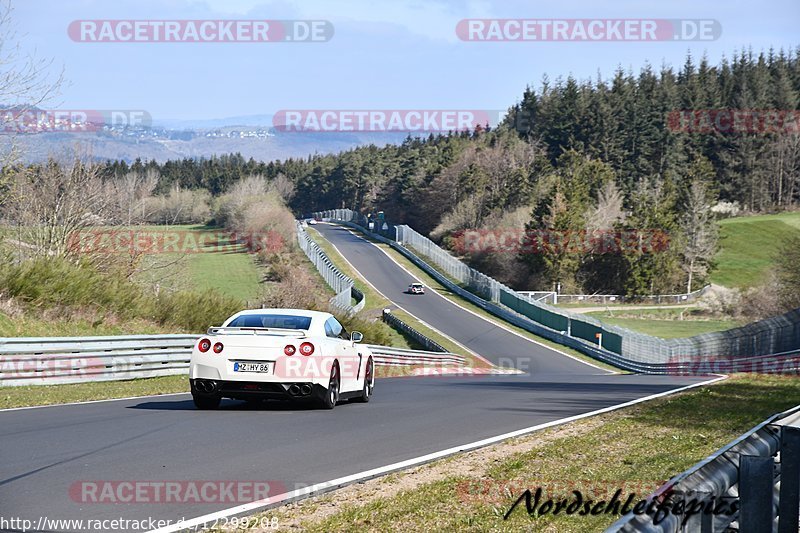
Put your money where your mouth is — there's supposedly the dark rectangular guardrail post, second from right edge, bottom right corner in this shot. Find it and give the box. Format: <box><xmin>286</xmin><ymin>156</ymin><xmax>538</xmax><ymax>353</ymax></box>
<box><xmin>739</xmin><ymin>455</ymin><xmax>774</xmax><ymax>533</ymax></box>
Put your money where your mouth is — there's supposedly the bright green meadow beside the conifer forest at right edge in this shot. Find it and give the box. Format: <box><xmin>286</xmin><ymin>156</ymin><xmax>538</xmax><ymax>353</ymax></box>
<box><xmin>711</xmin><ymin>212</ymin><xmax>800</xmax><ymax>288</ymax></box>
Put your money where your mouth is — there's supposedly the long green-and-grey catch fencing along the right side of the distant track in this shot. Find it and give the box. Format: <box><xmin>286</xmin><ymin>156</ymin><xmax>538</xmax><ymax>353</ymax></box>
<box><xmin>313</xmin><ymin>209</ymin><xmax>800</xmax><ymax>373</ymax></box>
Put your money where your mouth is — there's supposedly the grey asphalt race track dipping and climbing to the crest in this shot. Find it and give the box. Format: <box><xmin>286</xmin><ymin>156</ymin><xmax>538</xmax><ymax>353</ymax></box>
<box><xmin>0</xmin><ymin>225</ymin><xmax>703</xmax><ymax>530</ymax></box>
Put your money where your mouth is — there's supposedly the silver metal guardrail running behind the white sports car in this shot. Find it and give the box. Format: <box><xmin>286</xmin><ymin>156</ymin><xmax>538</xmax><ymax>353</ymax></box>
<box><xmin>0</xmin><ymin>335</ymin><xmax>465</xmax><ymax>387</ymax></box>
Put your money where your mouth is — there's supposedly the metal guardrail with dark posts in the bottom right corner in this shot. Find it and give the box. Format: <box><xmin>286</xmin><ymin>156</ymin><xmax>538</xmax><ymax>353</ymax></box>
<box><xmin>606</xmin><ymin>406</ymin><xmax>800</xmax><ymax>533</ymax></box>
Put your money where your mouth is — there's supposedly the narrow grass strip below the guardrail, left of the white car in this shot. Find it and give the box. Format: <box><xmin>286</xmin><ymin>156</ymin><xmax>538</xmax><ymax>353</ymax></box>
<box><xmin>0</xmin><ymin>376</ymin><xmax>189</xmax><ymax>409</ymax></box>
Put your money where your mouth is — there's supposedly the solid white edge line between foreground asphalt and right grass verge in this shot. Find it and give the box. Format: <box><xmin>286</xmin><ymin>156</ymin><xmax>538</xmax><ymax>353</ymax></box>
<box><xmin>150</xmin><ymin>377</ymin><xmax>727</xmax><ymax>533</ymax></box>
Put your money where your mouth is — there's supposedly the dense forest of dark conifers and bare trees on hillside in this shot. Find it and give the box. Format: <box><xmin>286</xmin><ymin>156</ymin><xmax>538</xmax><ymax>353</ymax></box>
<box><xmin>6</xmin><ymin>49</ymin><xmax>800</xmax><ymax>295</ymax></box>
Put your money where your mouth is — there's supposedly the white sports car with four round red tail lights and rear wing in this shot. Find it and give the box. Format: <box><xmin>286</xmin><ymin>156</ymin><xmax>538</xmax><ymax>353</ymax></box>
<box><xmin>189</xmin><ymin>309</ymin><xmax>375</xmax><ymax>409</ymax></box>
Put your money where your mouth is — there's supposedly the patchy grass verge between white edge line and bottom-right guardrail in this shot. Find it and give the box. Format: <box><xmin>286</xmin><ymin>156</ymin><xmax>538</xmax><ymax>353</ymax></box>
<box><xmin>253</xmin><ymin>375</ymin><xmax>800</xmax><ymax>533</ymax></box>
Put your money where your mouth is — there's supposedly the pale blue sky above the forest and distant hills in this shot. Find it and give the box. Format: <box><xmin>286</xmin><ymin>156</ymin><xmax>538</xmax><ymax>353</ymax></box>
<box><xmin>12</xmin><ymin>0</ymin><xmax>800</xmax><ymax>120</ymax></box>
